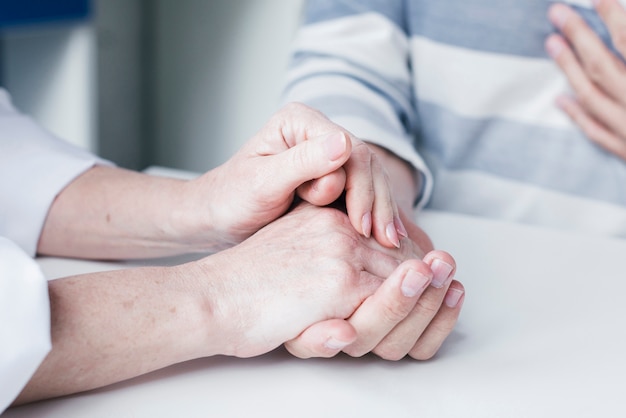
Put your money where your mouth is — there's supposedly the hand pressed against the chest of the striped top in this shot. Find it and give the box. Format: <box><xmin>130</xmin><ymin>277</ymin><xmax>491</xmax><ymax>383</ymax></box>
<box><xmin>546</xmin><ymin>0</ymin><xmax>626</xmax><ymax>160</ymax></box>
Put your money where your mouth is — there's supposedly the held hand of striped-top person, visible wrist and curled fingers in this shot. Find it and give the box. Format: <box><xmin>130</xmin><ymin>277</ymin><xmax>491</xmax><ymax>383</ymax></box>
<box><xmin>285</xmin><ymin>144</ymin><xmax>465</xmax><ymax>360</ymax></box>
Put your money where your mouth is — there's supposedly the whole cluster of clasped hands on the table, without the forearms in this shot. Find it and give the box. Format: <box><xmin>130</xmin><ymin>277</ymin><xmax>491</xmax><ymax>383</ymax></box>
<box><xmin>184</xmin><ymin>104</ymin><xmax>464</xmax><ymax>359</ymax></box>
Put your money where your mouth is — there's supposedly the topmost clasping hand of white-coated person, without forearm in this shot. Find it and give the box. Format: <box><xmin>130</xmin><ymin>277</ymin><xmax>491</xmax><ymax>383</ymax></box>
<box><xmin>183</xmin><ymin>104</ymin><xmax>405</xmax><ymax>248</ymax></box>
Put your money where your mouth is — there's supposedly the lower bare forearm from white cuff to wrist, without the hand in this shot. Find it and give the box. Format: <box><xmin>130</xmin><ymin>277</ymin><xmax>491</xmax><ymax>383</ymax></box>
<box><xmin>16</xmin><ymin>264</ymin><xmax>214</xmax><ymax>403</ymax></box>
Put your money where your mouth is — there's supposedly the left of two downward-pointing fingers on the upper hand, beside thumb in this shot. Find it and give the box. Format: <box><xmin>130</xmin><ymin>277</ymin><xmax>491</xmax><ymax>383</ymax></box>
<box><xmin>344</xmin><ymin>140</ymin><xmax>374</xmax><ymax>238</ymax></box>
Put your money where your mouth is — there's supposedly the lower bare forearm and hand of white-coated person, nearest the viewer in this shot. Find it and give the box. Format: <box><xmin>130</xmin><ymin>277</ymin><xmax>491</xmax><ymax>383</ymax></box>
<box><xmin>17</xmin><ymin>203</ymin><xmax>403</xmax><ymax>403</ymax></box>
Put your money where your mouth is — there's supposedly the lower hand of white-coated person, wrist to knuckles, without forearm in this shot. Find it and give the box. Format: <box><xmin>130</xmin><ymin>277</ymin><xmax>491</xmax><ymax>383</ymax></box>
<box><xmin>198</xmin><ymin>203</ymin><xmax>412</xmax><ymax>357</ymax></box>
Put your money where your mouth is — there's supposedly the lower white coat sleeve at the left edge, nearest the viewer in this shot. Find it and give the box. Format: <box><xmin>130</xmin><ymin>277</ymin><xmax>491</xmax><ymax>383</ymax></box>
<box><xmin>0</xmin><ymin>237</ymin><xmax>51</xmax><ymax>414</ymax></box>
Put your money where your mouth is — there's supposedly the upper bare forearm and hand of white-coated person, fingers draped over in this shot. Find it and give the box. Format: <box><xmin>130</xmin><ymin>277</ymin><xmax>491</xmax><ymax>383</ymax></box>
<box><xmin>37</xmin><ymin>104</ymin><xmax>405</xmax><ymax>259</ymax></box>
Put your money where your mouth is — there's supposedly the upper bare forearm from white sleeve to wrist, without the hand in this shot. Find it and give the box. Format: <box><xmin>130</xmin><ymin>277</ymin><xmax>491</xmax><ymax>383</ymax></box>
<box><xmin>38</xmin><ymin>167</ymin><xmax>214</xmax><ymax>259</ymax></box>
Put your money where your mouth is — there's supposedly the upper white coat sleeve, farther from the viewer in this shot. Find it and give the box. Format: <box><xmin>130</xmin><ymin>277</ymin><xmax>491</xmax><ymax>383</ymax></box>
<box><xmin>0</xmin><ymin>89</ymin><xmax>111</xmax><ymax>256</ymax></box>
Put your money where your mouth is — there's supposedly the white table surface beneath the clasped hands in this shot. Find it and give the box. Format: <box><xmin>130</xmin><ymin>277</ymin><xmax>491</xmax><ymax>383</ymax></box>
<box><xmin>3</xmin><ymin>212</ymin><xmax>626</xmax><ymax>418</ymax></box>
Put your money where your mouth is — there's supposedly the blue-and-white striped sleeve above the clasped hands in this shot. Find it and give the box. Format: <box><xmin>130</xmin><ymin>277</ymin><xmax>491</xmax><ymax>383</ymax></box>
<box><xmin>283</xmin><ymin>0</ymin><xmax>432</xmax><ymax>208</ymax></box>
